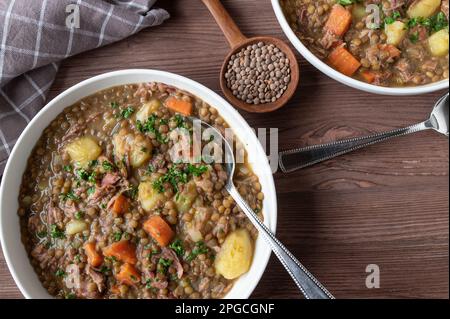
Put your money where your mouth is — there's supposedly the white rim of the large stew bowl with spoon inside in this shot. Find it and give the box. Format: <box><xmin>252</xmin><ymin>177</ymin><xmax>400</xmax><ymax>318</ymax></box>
<box><xmin>0</xmin><ymin>69</ymin><xmax>277</xmax><ymax>299</ymax></box>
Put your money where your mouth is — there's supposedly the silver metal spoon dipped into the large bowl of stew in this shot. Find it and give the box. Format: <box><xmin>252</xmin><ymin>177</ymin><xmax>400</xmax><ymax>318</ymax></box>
<box><xmin>189</xmin><ymin>117</ymin><xmax>334</xmax><ymax>299</ymax></box>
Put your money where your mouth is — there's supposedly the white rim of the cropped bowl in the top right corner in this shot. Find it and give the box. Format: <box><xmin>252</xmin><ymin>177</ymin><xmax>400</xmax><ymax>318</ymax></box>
<box><xmin>271</xmin><ymin>0</ymin><xmax>449</xmax><ymax>96</ymax></box>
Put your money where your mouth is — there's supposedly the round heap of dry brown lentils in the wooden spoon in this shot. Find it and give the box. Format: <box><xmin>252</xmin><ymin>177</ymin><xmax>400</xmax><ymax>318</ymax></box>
<box><xmin>225</xmin><ymin>42</ymin><xmax>291</xmax><ymax>104</ymax></box>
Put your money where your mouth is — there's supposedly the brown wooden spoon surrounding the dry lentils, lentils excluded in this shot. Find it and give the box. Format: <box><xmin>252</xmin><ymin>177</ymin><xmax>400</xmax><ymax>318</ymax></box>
<box><xmin>202</xmin><ymin>0</ymin><xmax>299</xmax><ymax>113</ymax></box>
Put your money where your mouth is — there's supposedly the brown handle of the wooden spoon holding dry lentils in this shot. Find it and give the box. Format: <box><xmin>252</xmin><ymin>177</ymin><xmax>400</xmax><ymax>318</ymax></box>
<box><xmin>202</xmin><ymin>0</ymin><xmax>247</xmax><ymax>48</ymax></box>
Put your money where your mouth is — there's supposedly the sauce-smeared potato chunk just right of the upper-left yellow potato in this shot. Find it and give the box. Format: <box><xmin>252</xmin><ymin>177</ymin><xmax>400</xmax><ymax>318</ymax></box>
<box><xmin>113</xmin><ymin>130</ymin><xmax>153</xmax><ymax>168</ymax></box>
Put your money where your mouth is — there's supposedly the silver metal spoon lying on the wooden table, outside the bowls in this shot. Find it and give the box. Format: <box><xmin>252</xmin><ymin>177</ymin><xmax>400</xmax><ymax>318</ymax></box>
<box><xmin>279</xmin><ymin>93</ymin><xmax>449</xmax><ymax>173</ymax></box>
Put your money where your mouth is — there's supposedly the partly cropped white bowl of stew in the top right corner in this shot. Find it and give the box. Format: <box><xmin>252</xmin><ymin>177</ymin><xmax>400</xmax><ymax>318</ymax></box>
<box><xmin>272</xmin><ymin>0</ymin><xmax>449</xmax><ymax>95</ymax></box>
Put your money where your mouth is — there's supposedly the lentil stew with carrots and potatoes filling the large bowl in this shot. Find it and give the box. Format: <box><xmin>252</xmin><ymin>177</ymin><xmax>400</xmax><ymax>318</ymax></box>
<box><xmin>18</xmin><ymin>83</ymin><xmax>264</xmax><ymax>299</ymax></box>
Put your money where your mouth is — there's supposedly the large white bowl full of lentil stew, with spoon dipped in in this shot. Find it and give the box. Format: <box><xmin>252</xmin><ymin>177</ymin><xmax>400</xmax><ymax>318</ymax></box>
<box><xmin>0</xmin><ymin>70</ymin><xmax>277</xmax><ymax>299</ymax></box>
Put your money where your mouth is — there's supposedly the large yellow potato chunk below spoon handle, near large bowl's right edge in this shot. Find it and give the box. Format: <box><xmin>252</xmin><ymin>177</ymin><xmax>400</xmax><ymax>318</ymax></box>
<box><xmin>214</xmin><ymin>229</ymin><xmax>253</xmax><ymax>279</ymax></box>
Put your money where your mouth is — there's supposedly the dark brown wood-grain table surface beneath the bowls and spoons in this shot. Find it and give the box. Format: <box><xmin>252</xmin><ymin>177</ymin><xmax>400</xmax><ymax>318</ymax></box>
<box><xmin>0</xmin><ymin>0</ymin><xmax>449</xmax><ymax>298</ymax></box>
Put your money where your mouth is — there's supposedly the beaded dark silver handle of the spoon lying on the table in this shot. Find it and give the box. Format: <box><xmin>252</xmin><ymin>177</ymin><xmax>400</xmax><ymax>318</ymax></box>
<box><xmin>279</xmin><ymin>120</ymin><xmax>432</xmax><ymax>173</ymax></box>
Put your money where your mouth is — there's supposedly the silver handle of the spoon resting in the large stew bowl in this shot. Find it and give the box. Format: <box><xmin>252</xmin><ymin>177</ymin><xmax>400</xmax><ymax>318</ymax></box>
<box><xmin>227</xmin><ymin>185</ymin><xmax>334</xmax><ymax>299</ymax></box>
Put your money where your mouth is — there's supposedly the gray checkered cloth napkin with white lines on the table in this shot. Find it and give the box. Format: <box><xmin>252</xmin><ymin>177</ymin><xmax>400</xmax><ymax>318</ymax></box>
<box><xmin>0</xmin><ymin>0</ymin><xmax>169</xmax><ymax>178</ymax></box>
